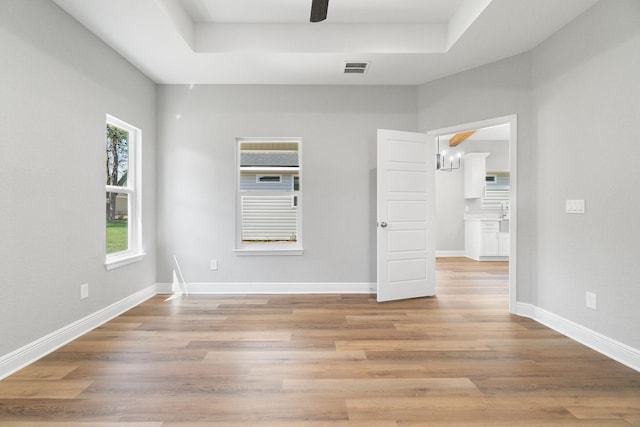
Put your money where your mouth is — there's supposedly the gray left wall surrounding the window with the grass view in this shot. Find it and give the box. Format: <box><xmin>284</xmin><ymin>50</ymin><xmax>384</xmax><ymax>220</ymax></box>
<box><xmin>0</xmin><ymin>0</ymin><xmax>156</xmax><ymax>355</ymax></box>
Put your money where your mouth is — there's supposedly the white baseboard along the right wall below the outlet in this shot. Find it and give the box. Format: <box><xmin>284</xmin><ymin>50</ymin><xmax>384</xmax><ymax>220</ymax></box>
<box><xmin>516</xmin><ymin>302</ymin><xmax>640</xmax><ymax>372</ymax></box>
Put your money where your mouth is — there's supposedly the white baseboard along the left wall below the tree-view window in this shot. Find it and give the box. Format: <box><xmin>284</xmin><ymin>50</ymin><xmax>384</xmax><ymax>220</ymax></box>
<box><xmin>0</xmin><ymin>284</ymin><xmax>158</xmax><ymax>380</ymax></box>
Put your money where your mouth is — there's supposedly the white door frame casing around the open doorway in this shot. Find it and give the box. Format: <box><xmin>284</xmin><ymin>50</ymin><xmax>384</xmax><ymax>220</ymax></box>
<box><xmin>427</xmin><ymin>114</ymin><xmax>518</xmax><ymax>314</ymax></box>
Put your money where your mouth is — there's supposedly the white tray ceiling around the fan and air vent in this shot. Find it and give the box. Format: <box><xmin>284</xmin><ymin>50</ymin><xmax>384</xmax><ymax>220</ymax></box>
<box><xmin>53</xmin><ymin>0</ymin><xmax>596</xmax><ymax>85</ymax></box>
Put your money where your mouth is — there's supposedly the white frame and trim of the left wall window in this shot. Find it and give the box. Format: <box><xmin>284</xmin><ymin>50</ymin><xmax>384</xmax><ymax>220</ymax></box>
<box><xmin>104</xmin><ymin>114</ymin><xmax>146</xmax><ymax>270</ymax></box>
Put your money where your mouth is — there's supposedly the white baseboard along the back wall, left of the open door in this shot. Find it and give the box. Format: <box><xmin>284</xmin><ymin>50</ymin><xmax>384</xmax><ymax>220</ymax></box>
<box><xmin>158</xmin><ymin>282</ymin><xmax>376</xmax><ymax>295</ymax></box>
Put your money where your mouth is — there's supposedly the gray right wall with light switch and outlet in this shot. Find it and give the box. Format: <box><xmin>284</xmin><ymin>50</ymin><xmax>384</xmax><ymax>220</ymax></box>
<box><xmin>533</xmin><ymin>0</ymin><xmax>640</xmax><ymax>348</ymax></box>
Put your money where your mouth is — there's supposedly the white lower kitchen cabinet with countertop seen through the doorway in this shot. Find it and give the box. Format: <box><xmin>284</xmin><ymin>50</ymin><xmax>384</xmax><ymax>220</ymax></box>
<box><xmin>464</xmin><ymin>219</ymin><xmax>509</xmax><ymax>261</ymax></box>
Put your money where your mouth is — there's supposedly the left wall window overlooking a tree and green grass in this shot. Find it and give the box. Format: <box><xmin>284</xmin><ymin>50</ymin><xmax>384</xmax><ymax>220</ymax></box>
<box><xmin>105</xmin><ymin>116</ymin><xmax>144</xmax><ymax>269</ymax></box>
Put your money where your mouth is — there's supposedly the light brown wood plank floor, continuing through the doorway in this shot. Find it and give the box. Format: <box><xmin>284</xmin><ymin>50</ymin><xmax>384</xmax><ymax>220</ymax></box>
<box><xmin>0</xmin><ymin>259</ymin><xmax>640</xmax><ymax>427</ymax></box>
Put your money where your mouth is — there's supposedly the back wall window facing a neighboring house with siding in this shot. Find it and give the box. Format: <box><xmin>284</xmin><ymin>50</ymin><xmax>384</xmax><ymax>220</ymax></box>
<box><xmin>235</xmin><ymin>138</ymin><xmax>302</xmax><ymax>255</ymax></box>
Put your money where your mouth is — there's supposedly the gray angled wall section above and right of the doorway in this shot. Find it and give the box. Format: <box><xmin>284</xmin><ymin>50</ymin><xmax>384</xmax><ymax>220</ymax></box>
<box><xmin>418</xmin><ymin>53</ymin><xmax>536</xmax><ymax>302</ymax></box>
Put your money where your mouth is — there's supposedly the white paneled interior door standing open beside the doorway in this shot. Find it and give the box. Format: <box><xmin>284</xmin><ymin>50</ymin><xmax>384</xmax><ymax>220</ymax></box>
<box><xmin>377</xmin><ymin>129</ymin><xmax>436</xmax><ymax>301</ymax></box>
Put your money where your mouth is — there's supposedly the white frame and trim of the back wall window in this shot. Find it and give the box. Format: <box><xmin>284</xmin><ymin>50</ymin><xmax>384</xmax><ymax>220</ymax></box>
<box><xmin>233</xmin><ymin>137</ymin><xmax>304</xmax><ymax>256</ymax></box>
